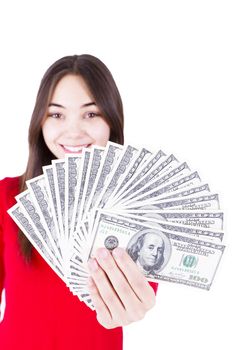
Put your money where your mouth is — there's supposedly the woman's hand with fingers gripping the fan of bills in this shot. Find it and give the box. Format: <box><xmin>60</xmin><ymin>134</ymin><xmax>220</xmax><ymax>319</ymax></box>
<box><xmin>88</xmin><ymin>248</ymin><xmax>155</xmax><ymax>329</ymax></box>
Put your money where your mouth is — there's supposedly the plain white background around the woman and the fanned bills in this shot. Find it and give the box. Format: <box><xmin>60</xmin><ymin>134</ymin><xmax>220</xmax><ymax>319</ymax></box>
<box><xmin>0</xmin><ymin>0</ymin><xmax>233</xmax><ymax>350</ymax></box>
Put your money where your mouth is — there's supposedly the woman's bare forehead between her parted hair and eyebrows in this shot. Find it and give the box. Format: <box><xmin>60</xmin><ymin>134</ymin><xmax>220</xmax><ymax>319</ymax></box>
<box><xmin>51</xmin><ymin>74</ymin><xmax>93</xmax><ymax>104</ymax></box>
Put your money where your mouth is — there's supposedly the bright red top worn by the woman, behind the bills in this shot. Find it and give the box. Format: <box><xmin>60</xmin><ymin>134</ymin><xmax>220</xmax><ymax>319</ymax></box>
<box><xmin>0</xmin><ymin>177</ymin><xmax>157</xmax><ymax>350</ymax></box>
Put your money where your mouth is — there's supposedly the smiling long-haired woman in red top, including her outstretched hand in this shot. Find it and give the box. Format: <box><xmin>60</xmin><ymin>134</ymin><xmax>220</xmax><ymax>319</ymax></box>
<box><xmin>0</xmin><ymin>55</ymin><xmax>157</xmax><ymax>350</ymax></box>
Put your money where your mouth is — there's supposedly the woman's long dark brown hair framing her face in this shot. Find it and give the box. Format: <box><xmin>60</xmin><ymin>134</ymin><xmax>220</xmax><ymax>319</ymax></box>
<box><xmin>19</xmin><ymin>54</ymin><xmax>124</xmax><ymax>260</ymax></box>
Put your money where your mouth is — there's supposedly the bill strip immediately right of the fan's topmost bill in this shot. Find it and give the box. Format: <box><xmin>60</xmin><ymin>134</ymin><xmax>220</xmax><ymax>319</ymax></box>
<box><xmin>96</xmin><ymin>145</ymin><xmax>138</xmax><ymax>208</ymax></box>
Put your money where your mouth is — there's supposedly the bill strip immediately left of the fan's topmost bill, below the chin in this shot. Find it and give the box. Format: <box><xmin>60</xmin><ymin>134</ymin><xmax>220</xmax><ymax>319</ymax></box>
<box><xmin>80</xmin><ymin>146</ymin><xmax>104</xmax><ymax>220</ymax></box>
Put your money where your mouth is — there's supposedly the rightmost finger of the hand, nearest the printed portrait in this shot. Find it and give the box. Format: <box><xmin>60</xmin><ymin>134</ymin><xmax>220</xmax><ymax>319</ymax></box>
<box><xmin>112</xmin><ymin>248</ymin><xmax>155</xmax><ymax>309</ymax></box>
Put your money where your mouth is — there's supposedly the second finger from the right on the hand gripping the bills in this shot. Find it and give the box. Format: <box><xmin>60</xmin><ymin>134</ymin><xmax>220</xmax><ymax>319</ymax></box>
<box><xmin>96</xmin><ymin>248</ymin><xmax>141</xmax><ymax>312</ymax></box>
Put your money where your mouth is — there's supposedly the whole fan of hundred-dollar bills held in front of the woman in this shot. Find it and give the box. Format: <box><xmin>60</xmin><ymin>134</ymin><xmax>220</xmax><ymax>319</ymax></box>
<box><xmin>8</xmin><ymin>142</ymin><xmax>225</xmax><ymax>309</ymax></box>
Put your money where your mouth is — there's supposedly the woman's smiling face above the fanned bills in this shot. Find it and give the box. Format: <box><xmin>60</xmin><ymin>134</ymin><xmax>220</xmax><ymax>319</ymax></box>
<box><xmin>42</xmin><ymin>74</ymin><xmax>110</xmax><ymax>158</ymax></box>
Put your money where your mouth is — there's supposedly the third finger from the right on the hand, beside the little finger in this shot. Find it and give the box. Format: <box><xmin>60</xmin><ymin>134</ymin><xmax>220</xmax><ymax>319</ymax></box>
<box><xmin>88</xmin><ymin>259</ymin><xmax>125</xmax><ymax>320</ymax></box>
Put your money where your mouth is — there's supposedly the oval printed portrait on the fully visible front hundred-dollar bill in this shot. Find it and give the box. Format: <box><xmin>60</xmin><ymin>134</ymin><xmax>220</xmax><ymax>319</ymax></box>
<box><xmin>126</xmin><ymin>228</ymin><xmax>171</xmax><ymax>277</ymax></box>
